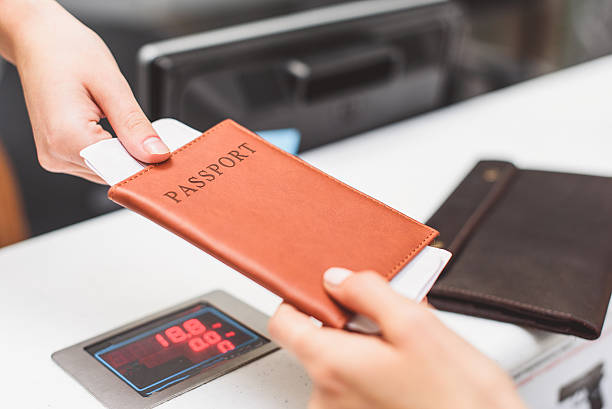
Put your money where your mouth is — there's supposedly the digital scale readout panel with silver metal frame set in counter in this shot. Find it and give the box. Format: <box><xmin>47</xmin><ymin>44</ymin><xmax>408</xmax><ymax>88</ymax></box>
<box><xmin>53</xmin><ymin>291</ymin><xmax>278</xmax><ymax>409</ymax></box>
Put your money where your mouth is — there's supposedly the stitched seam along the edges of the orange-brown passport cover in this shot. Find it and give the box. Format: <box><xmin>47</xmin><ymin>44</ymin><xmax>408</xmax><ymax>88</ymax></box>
<box><xmin>108</xmin><ymin>120</ymin><xmax>436</xmax><ymax>279</ymax></box>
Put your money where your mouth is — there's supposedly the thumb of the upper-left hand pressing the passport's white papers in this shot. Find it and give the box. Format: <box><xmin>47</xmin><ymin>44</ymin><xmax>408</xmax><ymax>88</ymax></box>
<box><xmin>91</xmin><ymin>69</ymin><xmax>170</xmax><ymax>163</ymax></box>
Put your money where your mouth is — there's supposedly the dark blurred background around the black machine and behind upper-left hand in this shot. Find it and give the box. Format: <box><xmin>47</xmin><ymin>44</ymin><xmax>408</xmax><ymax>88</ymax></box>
<box><xmin>0</xmin><ymin>0</ymin><xmax>612</xmax><ymax>241</ymax></box>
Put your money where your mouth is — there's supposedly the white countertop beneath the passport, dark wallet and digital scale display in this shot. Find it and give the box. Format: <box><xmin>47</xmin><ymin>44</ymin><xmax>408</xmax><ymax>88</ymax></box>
<box><xmin>0</xmin><ymin>57</ymin><xmax>612</xmax><ymax>408</ymax></box>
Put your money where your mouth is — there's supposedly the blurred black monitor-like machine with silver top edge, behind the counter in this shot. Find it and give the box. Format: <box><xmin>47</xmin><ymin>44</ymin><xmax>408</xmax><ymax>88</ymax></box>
<box><xmin>138</xmin><ymin>0</ymin><xmax>464</xmax><ymax>150</ymax></box>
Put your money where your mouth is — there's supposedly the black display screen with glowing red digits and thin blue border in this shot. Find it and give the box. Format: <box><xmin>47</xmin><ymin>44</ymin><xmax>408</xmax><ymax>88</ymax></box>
<box><xmin>85</xmin><ymin>303</ymin><xmax>269</xmax><ymax>397</ymax></box>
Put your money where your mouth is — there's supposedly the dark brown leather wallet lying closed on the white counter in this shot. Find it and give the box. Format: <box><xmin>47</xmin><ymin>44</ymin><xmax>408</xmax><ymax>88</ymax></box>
<box><xmin>427</xmin><ymin>161</ymin><xmax>612</xmax><ymax>339</ymax></box>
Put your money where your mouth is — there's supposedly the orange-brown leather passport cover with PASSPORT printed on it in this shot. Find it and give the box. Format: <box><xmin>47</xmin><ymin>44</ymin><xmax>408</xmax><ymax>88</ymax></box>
<box><xmin>108</xmin><ymin>120</ymin><xmax>438</xmax><ymax>328</ymax></box>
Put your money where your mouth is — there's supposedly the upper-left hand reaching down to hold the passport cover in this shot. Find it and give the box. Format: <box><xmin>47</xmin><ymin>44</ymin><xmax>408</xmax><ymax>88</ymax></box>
<box><xmin>0</xmin><ymin>0</ymin><xmax>170</xmax><ymax>183</ymax></box>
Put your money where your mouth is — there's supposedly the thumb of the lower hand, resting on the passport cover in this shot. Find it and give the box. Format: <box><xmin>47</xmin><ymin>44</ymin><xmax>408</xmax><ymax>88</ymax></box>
<box><xmin>324</xmin><ymin>267</ymin><xmax>427</xmax><ymax>341</ymax></box>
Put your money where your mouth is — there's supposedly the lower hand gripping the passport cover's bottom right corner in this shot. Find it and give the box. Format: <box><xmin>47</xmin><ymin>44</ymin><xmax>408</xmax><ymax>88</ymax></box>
<box><xmin>269</xmin><ymin>268</ymin><xmax>524</xmax><ymax>409</ymax></box>
